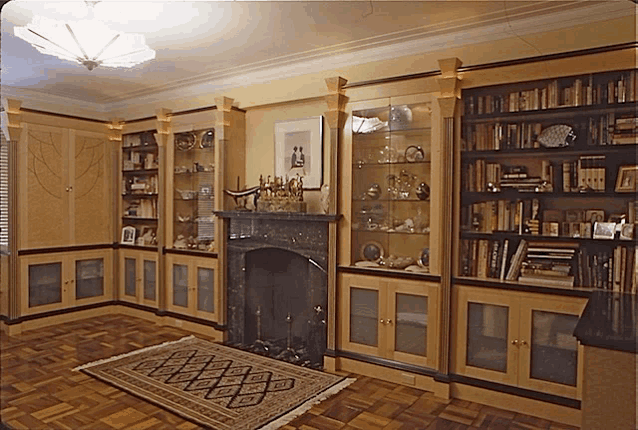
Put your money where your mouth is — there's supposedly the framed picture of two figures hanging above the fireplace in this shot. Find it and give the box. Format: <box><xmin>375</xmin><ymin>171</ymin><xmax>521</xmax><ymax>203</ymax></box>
<box><xmin>275</xmin><ymin>116</ymin><xmax>323</xmax><ymax>190</ymax></box>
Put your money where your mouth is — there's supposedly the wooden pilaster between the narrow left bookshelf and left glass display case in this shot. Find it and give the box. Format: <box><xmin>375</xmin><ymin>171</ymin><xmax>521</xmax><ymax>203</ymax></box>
<box><xmin>155</xmin><ymin>108</ymin><xmax>173</xmax><ymax>311</ymax></box>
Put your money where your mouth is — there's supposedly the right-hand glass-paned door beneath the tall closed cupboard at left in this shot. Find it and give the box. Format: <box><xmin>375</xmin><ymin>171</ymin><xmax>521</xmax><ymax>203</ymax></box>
<box><xmin>68</xmin><ymin>249</ymin><xmax>113</xmax><ymax>306</ymax></box>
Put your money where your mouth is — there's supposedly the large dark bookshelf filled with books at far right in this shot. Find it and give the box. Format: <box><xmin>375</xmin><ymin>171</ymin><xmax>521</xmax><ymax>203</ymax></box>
<box><xmin>458</xmin><ymin>70</ymin><xmax>638</xmax><ymax>294</ymax></box>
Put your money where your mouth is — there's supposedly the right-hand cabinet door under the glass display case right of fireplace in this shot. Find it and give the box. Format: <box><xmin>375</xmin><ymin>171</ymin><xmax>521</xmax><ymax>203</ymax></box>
<box><xmin>384</xmin><ymin>280</ymin><xmax>438</xmax><ymax>368</ymax></box>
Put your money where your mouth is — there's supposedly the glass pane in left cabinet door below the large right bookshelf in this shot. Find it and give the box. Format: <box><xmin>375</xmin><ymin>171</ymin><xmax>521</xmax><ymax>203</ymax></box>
<box><xmin>466</xmin><ymin>302</ymin><xmax>509</xmax><ymax>373</ymax></box>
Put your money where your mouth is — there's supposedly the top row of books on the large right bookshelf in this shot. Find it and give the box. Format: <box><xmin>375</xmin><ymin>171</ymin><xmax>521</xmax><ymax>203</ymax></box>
<box><xmin>464</xmin><ymin>70</ymin><xmax>638</xmax><ymax>115</ymax></box>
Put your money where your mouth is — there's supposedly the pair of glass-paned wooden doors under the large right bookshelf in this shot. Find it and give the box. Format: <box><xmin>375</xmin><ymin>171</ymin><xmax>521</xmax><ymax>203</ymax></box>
<box><xmin>452</xmin><ymin>286</ymin><xmax>587</xmax><ymax>399</ymax></box>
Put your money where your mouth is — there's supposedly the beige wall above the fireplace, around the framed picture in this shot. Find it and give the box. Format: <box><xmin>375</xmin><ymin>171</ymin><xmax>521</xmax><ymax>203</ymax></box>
<box><xmin>246</xmin><ymin>97</ymin><xmax>330</xmax><ymax>212</ymax></box>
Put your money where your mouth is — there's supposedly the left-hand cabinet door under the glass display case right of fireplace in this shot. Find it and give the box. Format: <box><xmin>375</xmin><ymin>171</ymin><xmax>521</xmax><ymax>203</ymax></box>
<box><xmin>339</xmin><ymin>275</ymin><xmax>387</xmax><ymax>357</ymax></box>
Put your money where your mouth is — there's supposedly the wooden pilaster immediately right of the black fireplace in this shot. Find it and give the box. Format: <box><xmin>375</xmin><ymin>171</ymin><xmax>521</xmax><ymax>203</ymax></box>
<box><xmin>324</xmin><ymin>76</ymin><xmax>348</xmax><ymax>371</ymax></box>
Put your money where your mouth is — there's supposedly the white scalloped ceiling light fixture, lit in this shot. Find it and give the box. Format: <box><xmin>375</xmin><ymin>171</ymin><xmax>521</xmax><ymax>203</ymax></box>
<box><xmin>14</xmin><ymin>1</ymin><xmax>155</xmax><ymax>70</ymax></box>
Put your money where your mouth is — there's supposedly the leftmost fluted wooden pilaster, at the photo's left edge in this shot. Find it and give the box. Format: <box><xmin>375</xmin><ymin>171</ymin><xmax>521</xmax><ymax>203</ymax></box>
<box><xmin>2</xmin><ymin>99</ymin><xmax>21</xmax><ymax>324</ymax></box>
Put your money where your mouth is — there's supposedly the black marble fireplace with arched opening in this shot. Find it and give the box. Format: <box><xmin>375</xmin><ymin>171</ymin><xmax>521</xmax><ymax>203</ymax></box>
<box><xmin>215</xmin><ymin>211</ymin><xmax>341</xmax><ymax>366</ymax></box>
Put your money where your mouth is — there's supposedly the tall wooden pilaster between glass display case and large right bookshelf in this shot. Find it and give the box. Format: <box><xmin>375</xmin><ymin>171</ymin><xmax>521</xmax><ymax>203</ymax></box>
<box><xmin>435</xmin><ymin>58</ymin><xmax>461</xmax><ymax>397</ymax></box>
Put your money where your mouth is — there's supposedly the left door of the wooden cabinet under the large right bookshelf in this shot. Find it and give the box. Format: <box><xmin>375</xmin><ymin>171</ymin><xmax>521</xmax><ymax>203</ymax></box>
<box><xmin>453</xmin><ymin>287</ymin><xmax>519</xmax><ymax>385</ymax></box>
